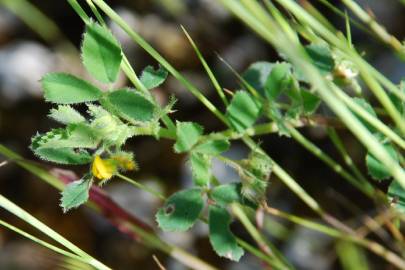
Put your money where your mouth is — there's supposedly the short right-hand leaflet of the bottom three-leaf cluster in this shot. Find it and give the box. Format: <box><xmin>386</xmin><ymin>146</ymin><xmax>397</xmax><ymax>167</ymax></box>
<box><xmin>210</xmin><ymin>183</ymin><xmax>255</xmax><ymax>208</ymax></box>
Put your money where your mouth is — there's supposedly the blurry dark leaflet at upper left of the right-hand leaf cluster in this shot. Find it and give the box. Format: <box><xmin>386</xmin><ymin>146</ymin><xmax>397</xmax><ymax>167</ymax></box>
<box><xmin>242</xmin><ymin>62</ymin><xmax>274</xmax><ymax>94</ymax></box>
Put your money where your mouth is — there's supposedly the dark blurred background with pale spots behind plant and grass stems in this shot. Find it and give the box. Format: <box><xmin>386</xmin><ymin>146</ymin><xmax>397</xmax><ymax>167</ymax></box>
<box><xmin>0</xmin><ymin>0</ymin><xmax>405</xmax><ymax>270</ymax></box>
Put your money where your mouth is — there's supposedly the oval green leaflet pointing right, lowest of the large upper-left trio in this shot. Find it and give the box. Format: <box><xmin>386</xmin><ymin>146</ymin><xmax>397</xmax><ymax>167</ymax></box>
<box><xmin>103</xmin><ymin>89</ymin><xmax>155</xmax><ymax>122</ymax></box>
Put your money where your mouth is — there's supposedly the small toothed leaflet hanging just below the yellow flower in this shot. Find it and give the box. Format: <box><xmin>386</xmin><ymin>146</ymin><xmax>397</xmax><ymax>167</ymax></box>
<box><xmin>60</xmin><ymin>177</ymin><xmax>91</xmax><ymax>213</ymax></box>
